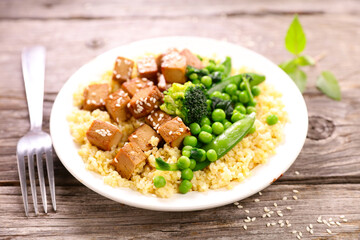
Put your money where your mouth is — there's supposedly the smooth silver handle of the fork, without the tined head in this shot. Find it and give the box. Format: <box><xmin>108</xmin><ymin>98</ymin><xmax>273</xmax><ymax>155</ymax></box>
<box><xmin>21</xmin><ymin>46</ymin><xmax>45</xmax><ymax>131</ymax></box>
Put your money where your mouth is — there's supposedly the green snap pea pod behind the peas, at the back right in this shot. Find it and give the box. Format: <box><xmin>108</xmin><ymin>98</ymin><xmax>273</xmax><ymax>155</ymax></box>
<box><xmin>207</xmin><ymin>73</ymin><xmax>265</xmax><ymax>95</ymax></box>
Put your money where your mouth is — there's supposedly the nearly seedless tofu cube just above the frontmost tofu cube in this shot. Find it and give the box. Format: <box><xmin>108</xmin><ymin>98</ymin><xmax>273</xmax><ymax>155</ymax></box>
<box><xmin>128</xmin><ymin>124</ymin><xmax>161</xmax><ymax>151</ymax></box>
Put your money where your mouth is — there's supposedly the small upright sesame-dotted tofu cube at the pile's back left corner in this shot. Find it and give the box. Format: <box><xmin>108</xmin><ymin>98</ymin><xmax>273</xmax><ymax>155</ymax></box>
<box><xmin>112</xmin><ymin>56</ymin><xmax>134</xmax><ymax>83</ymax></box>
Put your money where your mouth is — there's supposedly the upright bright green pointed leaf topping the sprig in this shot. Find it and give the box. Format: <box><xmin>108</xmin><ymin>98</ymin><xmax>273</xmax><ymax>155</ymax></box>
<box><xmin>285</xmin><ymin>15</ymin><xmax>306</xmax><ymax>55</ymax></box>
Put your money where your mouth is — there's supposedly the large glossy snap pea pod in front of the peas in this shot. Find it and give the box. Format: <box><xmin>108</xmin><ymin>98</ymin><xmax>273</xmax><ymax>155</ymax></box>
<box><xmin>193</xmin><ymin>113</ymin><xmax>255</xmax><ymax>171</ymax></box>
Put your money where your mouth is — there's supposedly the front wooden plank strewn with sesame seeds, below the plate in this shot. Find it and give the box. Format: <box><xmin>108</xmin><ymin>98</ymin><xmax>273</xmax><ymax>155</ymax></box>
<box><xmin>0</xmin><ymin>184</ymin><xmax>360</xmax><ymax>239</ymax></box>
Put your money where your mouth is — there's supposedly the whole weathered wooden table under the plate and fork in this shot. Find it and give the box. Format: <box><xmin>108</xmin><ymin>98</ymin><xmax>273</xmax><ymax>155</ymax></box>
<box><xmin>0</xmin><ymin>0</ymin><xmax>360</xmax><ymax>239</ymax></box>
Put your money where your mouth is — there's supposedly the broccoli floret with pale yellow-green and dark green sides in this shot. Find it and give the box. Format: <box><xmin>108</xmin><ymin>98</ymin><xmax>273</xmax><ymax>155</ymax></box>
<box><xmin>160</xmin><ymin>82</ymin><xmax>208</xmax><ymax>124</ymax></box>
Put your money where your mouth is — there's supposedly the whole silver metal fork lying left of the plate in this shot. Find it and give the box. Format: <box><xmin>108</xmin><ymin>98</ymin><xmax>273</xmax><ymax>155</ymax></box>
<box><xmin>16</xmin><ymin>46</ymin><xmax>56</xmax><ymax>216</ymax></box>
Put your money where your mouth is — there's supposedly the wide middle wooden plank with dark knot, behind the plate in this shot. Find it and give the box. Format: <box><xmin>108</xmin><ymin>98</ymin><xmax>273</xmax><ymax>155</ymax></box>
<box><xmin>0</xmin><ymin>15</ymin><xmax>360</xmax><ymax>185</ymax></box>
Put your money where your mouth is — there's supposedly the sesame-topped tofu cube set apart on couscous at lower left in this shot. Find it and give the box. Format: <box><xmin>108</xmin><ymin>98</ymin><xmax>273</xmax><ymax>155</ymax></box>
<box><xmin>86</xmin><ymin>120</ymin><xmax>121</xmax><ymax>151</ymax></box>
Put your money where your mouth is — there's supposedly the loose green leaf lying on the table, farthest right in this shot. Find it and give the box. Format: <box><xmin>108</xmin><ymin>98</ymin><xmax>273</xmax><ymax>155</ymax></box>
<box><xmin>316</xmin><ymin>71</ymin><xmax>341</xmax><ymax>101</ymax></box>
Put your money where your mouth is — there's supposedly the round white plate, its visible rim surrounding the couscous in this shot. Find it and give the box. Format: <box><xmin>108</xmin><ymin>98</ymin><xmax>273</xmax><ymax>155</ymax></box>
<box><xmin>50</xmin><ymin>37</ymin><xmax>308</xmax><ymax>211</ymax></box>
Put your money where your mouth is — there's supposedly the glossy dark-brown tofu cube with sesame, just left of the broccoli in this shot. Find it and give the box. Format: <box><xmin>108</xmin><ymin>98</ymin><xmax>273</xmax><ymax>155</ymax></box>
<box><xmin>128</xmin><ymin>86</ymin><xmax>163</xmax><ymax>118</ymax></box>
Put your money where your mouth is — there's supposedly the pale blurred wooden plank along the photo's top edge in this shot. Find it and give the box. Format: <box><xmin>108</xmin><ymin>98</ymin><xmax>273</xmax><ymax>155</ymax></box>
<box><xmin>0</xmin><ymin>0</ymin><xmax>360</xmax><ymax>20</ymax></box>
